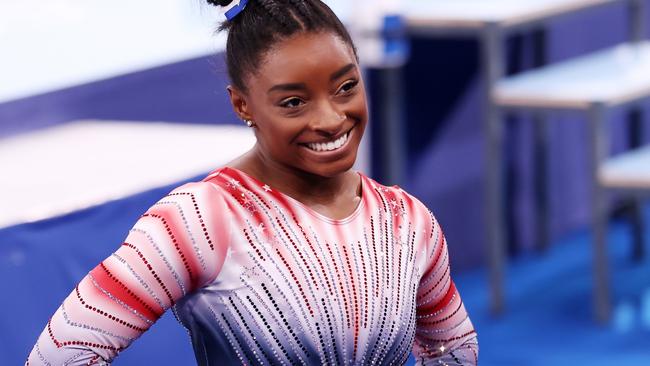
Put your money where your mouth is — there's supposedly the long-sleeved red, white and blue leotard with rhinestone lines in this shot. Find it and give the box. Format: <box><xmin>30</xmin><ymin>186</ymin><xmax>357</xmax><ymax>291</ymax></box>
<box><xmin>27</xmin><ymin>168</ymin><xmax>478</xmax><ymax>365</ymax></box>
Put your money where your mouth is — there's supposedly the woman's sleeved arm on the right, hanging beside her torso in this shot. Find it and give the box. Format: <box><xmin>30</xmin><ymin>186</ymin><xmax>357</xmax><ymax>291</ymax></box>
<box><xmin>413</xmin><ymin>215</ymin><xmax>478</xmax><ymax>365</ymax></box>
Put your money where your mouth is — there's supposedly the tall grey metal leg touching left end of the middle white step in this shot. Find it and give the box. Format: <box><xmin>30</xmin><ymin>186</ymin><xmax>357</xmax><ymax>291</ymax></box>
<box><xmin>482</xmin><ymin>24</ymin><xmax>506</xmax><ymax>314</ymax></box>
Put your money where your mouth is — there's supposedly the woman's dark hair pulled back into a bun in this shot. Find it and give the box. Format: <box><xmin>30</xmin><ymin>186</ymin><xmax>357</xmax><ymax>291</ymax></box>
<box><xmin>208</xmin><ymin>0</ymin><xmax>357</xmax><ymax>91</ymax></box>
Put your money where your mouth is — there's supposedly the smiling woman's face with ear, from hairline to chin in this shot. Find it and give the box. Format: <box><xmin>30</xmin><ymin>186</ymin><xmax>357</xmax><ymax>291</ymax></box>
<box><xmin>229</xmin><ymin>33</ymin><xmax>368</xmax><ymax>177</ymax></box>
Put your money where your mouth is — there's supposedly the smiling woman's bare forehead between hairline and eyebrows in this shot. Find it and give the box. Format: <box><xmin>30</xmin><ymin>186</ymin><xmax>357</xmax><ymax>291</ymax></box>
<box><xmin>253</xmin><ymin>33</ymin><xmax>356</xmax><ymax>85</ymax></box>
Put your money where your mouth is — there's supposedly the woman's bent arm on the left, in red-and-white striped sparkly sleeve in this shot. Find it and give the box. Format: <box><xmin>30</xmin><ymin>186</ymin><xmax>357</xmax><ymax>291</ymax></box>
<box><xmin>27</xmin><ymin>183</ymin><xmax>230</xmax><ymax>365</ymax></box>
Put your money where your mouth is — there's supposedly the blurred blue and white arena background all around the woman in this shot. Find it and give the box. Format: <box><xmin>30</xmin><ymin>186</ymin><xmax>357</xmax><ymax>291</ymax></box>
<box><xmin>0</xmin><ymin>0</ymin><xmax>650</xmax><ymax>365</ymax></box>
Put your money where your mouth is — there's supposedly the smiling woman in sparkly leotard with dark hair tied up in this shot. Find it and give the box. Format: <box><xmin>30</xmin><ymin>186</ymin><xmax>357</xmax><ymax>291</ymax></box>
<box><xmin>28</xmin><ymin>0</ymin><xmax>478</xmax><ymax>365</ymax></box>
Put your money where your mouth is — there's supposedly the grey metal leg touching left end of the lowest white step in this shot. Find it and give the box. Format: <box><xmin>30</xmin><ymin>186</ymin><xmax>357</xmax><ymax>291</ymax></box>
<box><xmin>589</xmin><ymin>104</ymin><xmax>611</xmax><ymax>323</ymax></box>
